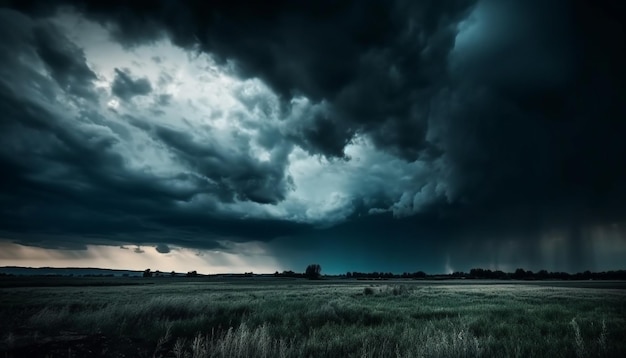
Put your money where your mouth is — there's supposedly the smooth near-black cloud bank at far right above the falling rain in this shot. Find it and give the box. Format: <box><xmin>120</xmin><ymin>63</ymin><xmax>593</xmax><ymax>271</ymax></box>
<box><xmin>432</xmin><ymin>2</ymin><xmax>626</xmax><ymax>217</ymax></box>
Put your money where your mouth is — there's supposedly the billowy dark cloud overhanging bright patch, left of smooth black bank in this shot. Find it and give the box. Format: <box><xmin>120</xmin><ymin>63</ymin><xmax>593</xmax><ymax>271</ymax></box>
<box><xmin>7</xmin><ymin>1</ymin><xmax>474</xmax><ymax>159</ymax></box>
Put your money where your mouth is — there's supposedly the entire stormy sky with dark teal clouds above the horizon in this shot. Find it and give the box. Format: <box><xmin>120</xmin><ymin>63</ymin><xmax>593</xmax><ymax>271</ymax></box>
<box><xmin>0</xmin><ymin>0</ymin><xmax>626</xmax><ymax>273</ymax></box>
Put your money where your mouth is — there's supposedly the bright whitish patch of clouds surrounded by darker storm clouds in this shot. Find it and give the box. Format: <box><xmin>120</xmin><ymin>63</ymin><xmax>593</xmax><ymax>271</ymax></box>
<box><xmin>44</xmin><ymin>9</ymin><xmax>435</xmax><ymax>225</ymax></box>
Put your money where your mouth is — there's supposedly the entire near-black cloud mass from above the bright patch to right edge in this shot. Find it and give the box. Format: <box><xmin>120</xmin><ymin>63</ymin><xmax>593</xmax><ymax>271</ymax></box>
<box><xmin>96</xmin><ymin>1</ymin><xmax>626</xmax><ymax>217</ymax></box>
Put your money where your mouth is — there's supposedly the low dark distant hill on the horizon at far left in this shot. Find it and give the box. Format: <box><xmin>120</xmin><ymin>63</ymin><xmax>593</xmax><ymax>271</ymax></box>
<box><xmin>0</xmin><ymin>266</ymin><xmax>143</xmax><ymax>277</ymax></box>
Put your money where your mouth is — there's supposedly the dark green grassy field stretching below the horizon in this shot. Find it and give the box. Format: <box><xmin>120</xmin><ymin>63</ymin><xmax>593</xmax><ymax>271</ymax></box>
<box><xmin>0</xmin><ymin>278</ymin><xmax>626</xmax><ymax>357</ymax></box>
